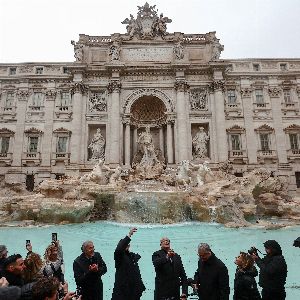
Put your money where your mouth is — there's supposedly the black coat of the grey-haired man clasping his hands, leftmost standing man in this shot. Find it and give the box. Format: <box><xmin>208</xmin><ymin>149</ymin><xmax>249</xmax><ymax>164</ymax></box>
<box><xmin>73</xmin><ymin>252</ymin><xmax>107</xmax><ymax>300</ymax></box>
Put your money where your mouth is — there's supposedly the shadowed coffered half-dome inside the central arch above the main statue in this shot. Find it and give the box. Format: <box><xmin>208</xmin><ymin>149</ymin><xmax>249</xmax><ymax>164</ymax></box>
<box><xmin>130</xmin><ymin>96</ymin><xmax>167</xmax><ymax>125</ymax></box>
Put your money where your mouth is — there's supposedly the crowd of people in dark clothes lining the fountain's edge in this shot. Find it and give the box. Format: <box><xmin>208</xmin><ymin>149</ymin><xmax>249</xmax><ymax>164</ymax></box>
<box><xmin>0</xmin><ymin>228</ymin><xmax>287</xmax><ymax>300</ymax></box>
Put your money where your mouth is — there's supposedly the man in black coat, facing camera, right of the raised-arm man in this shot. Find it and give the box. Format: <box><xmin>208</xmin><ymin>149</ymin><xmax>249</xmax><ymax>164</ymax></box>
<box><xmin>152</xmin><ymin>237</ymin><xmax>188</xmax><ymax>300</ymax></box>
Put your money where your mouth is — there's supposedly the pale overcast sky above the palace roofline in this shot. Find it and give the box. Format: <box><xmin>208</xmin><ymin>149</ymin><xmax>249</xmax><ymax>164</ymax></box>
<box><xmin>0</xmin><ymin>0</ymin><xmax>300</xmax><ymax>63</ymax></box>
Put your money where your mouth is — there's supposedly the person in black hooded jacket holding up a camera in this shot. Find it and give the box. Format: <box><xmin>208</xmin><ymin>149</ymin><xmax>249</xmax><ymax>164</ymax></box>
<box><xmin>253</xmin><ymin>240</ymin><xmax>287</xmax><ymax>300</ymax></box>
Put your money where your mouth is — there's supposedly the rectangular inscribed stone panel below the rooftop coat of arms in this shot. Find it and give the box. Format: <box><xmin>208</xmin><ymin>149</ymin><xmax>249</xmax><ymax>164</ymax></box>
<box><xmin>122</xmin><ymin>48</ymin><xmax>173</xmax><ymax>61</ymax></box>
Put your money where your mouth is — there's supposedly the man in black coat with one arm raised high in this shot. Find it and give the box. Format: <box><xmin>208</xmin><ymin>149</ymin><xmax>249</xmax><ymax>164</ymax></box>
<box><xmin>111</xmin><ymin>228</ymin><xmax>145</xmax><ymax>300</ymax></box>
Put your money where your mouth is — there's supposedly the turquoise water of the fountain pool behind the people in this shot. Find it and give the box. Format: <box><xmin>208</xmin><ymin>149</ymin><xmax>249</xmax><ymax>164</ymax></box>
<box><xmin>0</xmin><ymin>222</ymin><xmax>300</xmax><ymax>300</ymax></box>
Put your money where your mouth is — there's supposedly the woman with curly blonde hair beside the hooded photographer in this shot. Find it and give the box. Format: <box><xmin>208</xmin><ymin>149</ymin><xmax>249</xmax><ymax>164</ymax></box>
<box><xmin>233</xmin><ymin>252</ymin><xmax>261</xmax><ymax>300</ymax></box>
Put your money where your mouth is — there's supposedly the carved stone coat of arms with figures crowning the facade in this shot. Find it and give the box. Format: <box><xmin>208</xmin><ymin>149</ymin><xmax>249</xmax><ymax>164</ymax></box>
<box><xmin>122</xmin><ymin>2</ymin><xmax>172</xmax><ymax>39</ymax></box>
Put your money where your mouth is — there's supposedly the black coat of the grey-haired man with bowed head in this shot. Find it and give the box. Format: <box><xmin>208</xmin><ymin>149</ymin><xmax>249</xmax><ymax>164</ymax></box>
<box><xmin>194</xmin><ymin>253</ymin><xmax>230</xmax><ymax>300</ymax></box>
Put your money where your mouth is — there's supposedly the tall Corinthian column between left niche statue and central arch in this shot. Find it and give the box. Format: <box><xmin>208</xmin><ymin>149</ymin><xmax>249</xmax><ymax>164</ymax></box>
<box><xmin>107</xmin><ymin>80</ymin><xmax>121</xmax><ymax>165</ymax></box>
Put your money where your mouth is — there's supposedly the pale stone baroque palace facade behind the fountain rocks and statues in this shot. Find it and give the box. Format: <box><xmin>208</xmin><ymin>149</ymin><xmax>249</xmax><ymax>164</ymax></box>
<box><xmin>0</xmin><ymin>3</ymin><xmax>300</xmax><ymax>191</ymax></box>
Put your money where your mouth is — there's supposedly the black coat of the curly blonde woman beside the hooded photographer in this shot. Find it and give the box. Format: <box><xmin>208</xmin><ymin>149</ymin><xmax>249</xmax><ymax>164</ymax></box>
<box><xmin>233</xmin><ymin>268</ymin><xmax>261</xmax><ymax>300</ymax></box>
